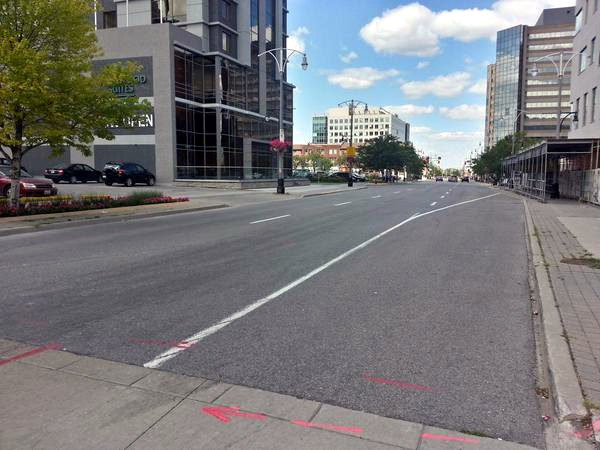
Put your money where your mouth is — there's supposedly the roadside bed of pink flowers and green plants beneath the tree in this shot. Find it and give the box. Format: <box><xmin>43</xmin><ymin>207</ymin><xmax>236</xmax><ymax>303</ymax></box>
<box><xmin>0</xmin><ymin>191</ymin><xmax>189</xmax><ymax>217</ymax></box>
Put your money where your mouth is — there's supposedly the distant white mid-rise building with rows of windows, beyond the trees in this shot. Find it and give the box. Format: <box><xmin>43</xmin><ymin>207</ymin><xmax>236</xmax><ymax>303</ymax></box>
<box><xmin>327</xmin><ymin>107</ymin><xmax>410</xmax><ymax>146</ymax></box>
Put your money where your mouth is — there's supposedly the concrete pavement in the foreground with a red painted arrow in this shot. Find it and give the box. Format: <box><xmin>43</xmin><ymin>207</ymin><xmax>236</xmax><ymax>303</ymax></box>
<box><xmin>0</xmin><ymin>340</ymin><xmax>531</xmax><ymax>449</ymax></box>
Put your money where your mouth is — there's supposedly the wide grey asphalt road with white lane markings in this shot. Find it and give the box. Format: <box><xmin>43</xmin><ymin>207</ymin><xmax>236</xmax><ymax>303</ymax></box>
<box><xmin>0</xmin><ymin>183</ymin><xmax>542</xmax><ymax>445</ymax></box>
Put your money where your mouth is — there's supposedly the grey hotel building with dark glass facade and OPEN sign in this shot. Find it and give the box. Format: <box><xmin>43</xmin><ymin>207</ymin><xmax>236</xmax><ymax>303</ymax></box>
<box><xmin>23</xmin><ymin>0</ymin><xmax>293</xmax><ymax>183</ymax></box>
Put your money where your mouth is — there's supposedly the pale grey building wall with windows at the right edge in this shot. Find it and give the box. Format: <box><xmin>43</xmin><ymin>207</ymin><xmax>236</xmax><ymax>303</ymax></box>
<box><xmin>569</xmin><ymin>0</ymin><xmax>600</xmax><ymax>138</ymax></box>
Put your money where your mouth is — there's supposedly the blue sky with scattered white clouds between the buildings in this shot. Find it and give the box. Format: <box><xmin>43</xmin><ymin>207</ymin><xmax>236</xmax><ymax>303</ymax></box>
<box><xmin>288</xmin><ymin>0</ymin><xmax>575</xmax><ymax>167</ymax></box>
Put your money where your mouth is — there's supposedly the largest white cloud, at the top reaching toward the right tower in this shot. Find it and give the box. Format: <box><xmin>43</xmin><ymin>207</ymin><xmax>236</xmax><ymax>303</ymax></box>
<box><xmin>360</xmin><ymin>0</ymin><xmax>574</xmax><ymax>57</ymax></box>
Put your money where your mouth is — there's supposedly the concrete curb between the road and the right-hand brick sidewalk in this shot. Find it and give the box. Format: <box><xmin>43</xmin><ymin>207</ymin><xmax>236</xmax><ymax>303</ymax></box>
<box><xmin>523</xmin><ymin>199</ymin><xmax>588</xmax><ymax>422</ymax></box>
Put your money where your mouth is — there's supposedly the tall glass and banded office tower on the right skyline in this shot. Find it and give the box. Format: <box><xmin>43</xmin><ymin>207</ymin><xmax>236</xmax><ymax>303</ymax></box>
<box><xmin>486</xmin><ymin>7</ymin><xmax>575</xmax><ymax>148</ymax></box>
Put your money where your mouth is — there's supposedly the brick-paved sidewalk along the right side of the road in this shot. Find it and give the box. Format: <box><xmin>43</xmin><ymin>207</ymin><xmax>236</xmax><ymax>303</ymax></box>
<box><xmin>528</xmin><ymin>200</ymin><xmax>600</xmax><ymax>409</ymax></box>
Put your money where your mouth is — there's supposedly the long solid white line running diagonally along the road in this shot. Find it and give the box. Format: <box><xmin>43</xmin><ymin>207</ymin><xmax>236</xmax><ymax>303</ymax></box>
<box><xmin>144</xmin><ymin>193</ymin><xmax>499</xmax><ymax>369</ymax></box>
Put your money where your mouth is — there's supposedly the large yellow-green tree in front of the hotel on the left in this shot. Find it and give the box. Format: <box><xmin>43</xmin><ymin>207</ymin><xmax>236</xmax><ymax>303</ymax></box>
<box><xmin>0</xmin><ymin>0</ymin><xmax>149</xmax><ymax>207</ymax></box>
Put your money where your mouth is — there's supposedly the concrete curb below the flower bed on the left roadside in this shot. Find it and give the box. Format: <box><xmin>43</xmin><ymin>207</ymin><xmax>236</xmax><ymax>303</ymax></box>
<box><xmin>0</xmin><ymin>203</ymin><xmax>230</xmax><ymax>237</ymax></box>
